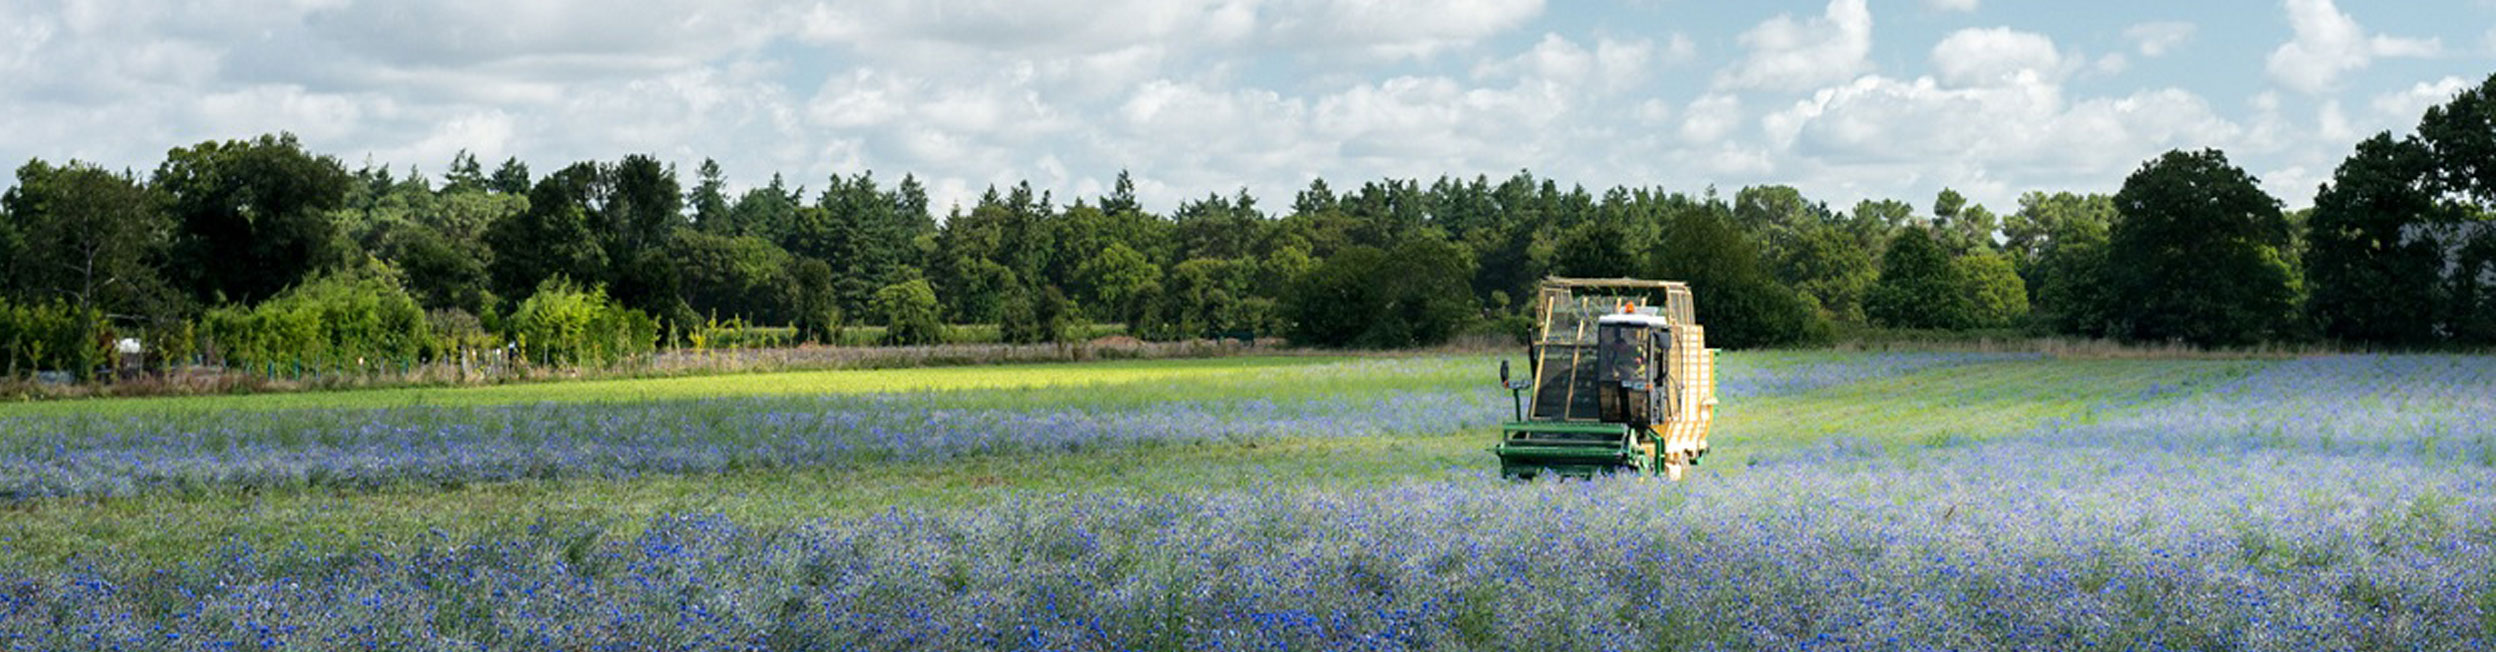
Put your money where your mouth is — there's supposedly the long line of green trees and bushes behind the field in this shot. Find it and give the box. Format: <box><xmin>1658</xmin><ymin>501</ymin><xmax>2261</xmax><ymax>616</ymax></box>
<box><xmin>0</xmin><ymin>77</ymin><xmax>2496</xmax><ymax>375</ymax></box>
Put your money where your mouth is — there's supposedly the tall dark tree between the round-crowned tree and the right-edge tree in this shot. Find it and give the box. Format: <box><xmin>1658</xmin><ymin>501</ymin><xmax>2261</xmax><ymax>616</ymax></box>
<box><xmin>2304</xmin><ymin>132</ymin><xmax>2451</xmax><ymax>345</ymax></box>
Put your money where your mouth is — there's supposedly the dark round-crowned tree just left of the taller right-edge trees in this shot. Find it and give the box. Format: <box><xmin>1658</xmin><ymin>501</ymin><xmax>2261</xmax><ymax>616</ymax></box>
<box><xmin>2107</xmin><ymin>150</ymin><xmax>2296</xmax><ymax>347</ymax></box>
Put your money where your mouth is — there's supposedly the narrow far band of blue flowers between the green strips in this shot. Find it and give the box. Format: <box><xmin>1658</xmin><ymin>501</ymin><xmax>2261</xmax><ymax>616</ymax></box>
<box><xmin>0</xmin><ymin>355</ymin><xmax>1984</xmax><ymax>500</ymax></box>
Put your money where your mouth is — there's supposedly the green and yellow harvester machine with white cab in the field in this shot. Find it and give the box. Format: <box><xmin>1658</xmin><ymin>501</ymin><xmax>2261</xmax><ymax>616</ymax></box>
<box><xmin>1490</xmin><ymin>277</ymin><xmax>1715</xmax><ymax>480</ymax></box>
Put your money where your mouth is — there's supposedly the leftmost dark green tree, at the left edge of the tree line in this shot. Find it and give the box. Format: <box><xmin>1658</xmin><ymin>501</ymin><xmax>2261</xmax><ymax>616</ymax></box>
<box><xmin>0</xmin><ymin>160</ymin><xmax>177</xmax><ymax>317</ymax></box>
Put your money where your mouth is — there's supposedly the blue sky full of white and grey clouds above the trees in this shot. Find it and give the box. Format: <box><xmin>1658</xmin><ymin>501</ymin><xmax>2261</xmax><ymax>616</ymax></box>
<box><xmin>0</xmin><ymin>0</ymin><xmax>2496</xmax><ymax>212</ymax></box>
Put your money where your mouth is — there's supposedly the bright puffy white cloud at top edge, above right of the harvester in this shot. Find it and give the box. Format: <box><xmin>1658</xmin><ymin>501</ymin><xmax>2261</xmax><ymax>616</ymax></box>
<box><xmin>1717</xmin><ymin>0</ymin><xmax>1872</xmax><ymax>90</ymax></box>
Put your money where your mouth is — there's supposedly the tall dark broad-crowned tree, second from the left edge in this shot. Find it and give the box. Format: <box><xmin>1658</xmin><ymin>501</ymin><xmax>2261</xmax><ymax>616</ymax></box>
<box><xmin>155</xmin><ymin>135</ymin><xmax>354</xmax><ymax>302</ymax></box>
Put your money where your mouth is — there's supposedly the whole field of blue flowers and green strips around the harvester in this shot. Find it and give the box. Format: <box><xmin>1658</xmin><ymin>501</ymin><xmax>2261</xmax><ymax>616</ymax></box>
<box><xmin>0</xmin><ymin>352</ymin><xmax>2496</xmax><ymax>650</ymax></box>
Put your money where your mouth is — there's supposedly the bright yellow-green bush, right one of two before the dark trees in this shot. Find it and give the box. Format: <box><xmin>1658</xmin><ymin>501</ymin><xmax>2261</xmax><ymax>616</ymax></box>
<box><xmin>504</xmin><ymin>277</ymin><xmax>659</xmax><ymax>365</ymax></box>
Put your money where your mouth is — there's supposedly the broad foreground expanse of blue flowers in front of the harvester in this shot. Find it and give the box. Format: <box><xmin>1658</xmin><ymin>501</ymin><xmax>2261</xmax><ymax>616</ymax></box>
<box><xmin>0</xmin><ymin>357</ymin><xmax>2496</xmax><ymax>650</ymax></box>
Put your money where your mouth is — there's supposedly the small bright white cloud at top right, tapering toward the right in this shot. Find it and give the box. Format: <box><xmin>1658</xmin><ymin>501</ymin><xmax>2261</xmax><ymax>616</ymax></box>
<box><xmin>2266</xmin><ymin>0</ymin><xmax>2444</xmax><ymax>95</ymax></box>
